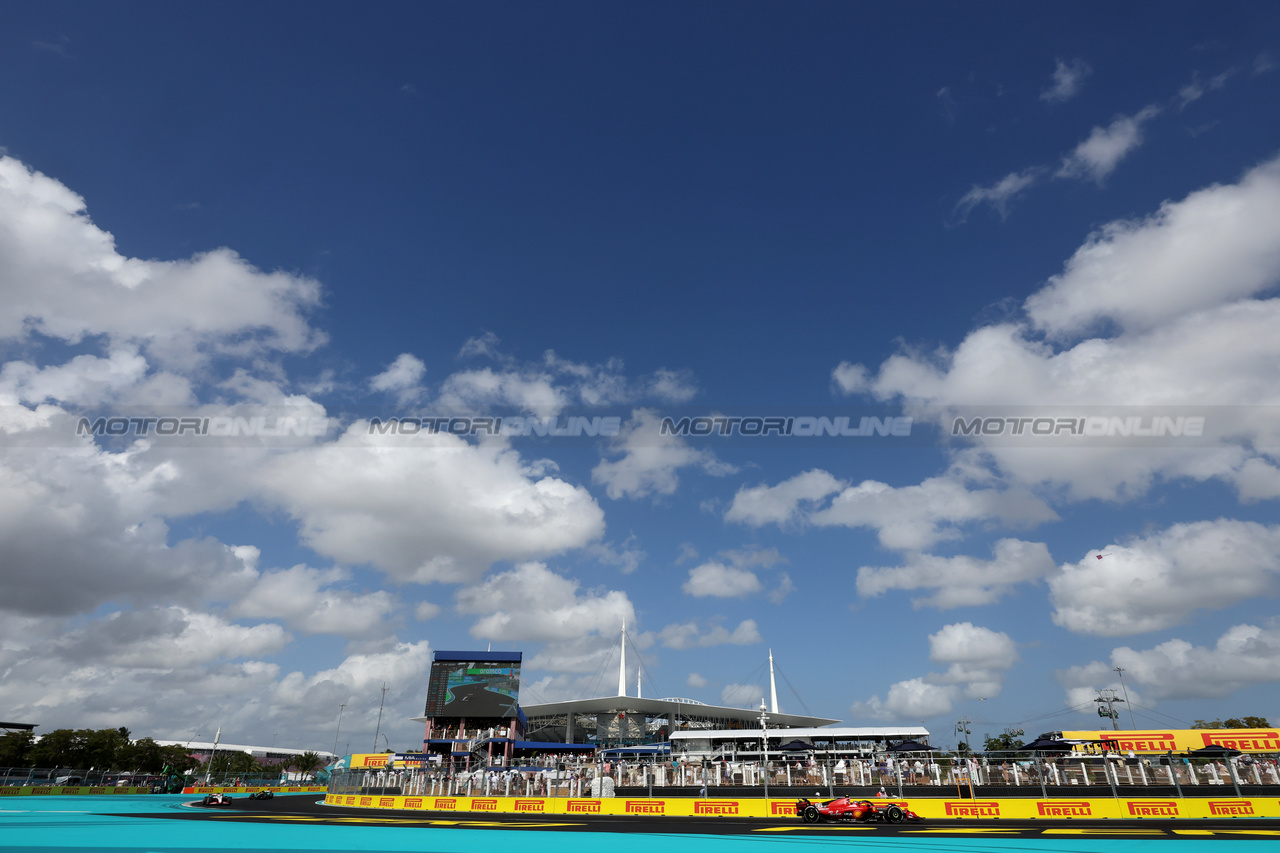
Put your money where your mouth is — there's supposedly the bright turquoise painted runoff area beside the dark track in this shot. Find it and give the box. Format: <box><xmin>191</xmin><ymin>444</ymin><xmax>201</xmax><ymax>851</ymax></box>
<box><xmin>0</xmin><ymin>794</ymin><xmax>1254</xmax><ymax>853</ymax></box>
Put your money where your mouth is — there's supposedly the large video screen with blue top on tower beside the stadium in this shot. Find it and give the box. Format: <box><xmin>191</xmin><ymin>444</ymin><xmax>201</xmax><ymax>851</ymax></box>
<box><xmin>426</xmin><ymin>652</ymin><xmax>521</xmax><ymax>719</ymax></box>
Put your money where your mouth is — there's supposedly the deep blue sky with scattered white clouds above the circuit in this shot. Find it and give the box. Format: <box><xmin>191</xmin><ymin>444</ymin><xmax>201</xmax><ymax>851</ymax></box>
<box><xmin>0</xmin><ymin>3</ymin><xmax>1280</xmax><ymax>748</ymax></box>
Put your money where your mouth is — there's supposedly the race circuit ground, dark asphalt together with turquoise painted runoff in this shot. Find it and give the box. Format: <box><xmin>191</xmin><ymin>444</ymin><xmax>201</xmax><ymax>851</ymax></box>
<box><xmin>0</xmin><ymin>794</ymin><xmax>1280</xmax><ymax>853</ymax></box>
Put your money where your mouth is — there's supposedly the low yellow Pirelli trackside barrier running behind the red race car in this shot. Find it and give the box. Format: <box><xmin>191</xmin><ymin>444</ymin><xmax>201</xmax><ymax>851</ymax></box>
<box><xmin>324</xmin><ymin>794</ymin><xmax>1280</xmax><ymax>820</ymax></box>
